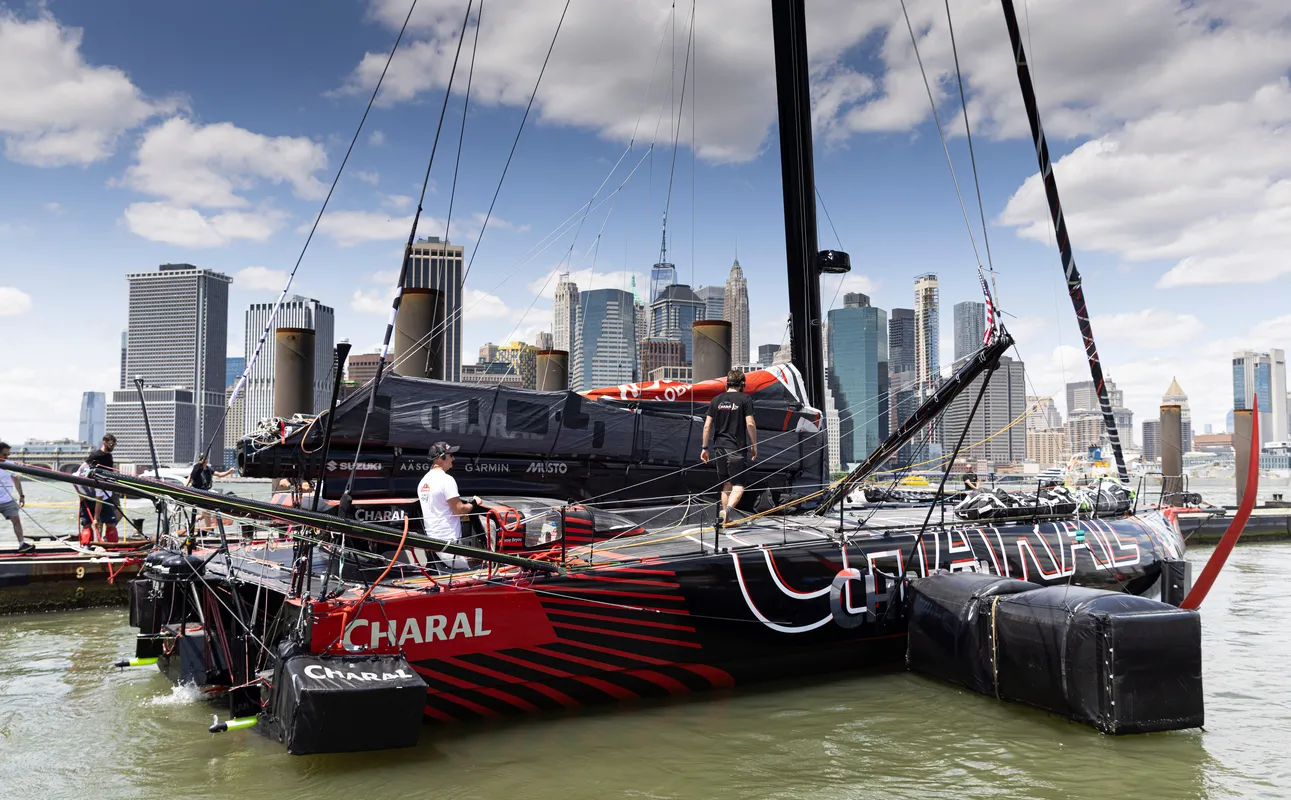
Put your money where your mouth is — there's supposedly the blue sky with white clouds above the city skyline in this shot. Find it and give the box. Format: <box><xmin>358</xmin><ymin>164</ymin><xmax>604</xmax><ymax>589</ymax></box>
<box><xmin>0</xmin><ymin>0</ymin><xmax>1291</xmax><ymax>441</ymax></box>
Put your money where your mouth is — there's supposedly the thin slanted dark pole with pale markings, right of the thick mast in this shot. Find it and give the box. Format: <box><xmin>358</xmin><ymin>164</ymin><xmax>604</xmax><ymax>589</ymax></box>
<box><xmin>1001</xmin><ymin>0</ymin><xmax>1130</xmax><ymax>484</ymax></box>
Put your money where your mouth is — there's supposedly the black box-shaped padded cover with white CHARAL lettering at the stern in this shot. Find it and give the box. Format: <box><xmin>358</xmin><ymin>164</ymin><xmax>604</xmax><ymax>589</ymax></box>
<box><xmin>267</xmin><ymin>655</ymin><xmax>426</xmax><ymax>755</ymax></box>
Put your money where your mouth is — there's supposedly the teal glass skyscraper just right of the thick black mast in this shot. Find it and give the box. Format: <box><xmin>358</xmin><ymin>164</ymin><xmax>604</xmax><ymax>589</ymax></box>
<box><xmin>826</xmin><ymin>293</ymin><xmax>888</xmax><ymax>468</ymax></box>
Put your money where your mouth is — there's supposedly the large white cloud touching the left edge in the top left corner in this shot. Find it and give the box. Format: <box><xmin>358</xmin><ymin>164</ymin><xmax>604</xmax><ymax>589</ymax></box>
<box><xmin>0</xmin><ymin>10</ymin><xmax>179</xmax><ymax>166</ymax></box>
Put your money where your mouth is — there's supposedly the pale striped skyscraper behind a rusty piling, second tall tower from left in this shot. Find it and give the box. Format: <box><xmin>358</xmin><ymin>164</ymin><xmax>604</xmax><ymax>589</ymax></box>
<box><xmin>241</xmin><ymin>294</ymin><xmax>336</xmax><ymax>434</ymax></box>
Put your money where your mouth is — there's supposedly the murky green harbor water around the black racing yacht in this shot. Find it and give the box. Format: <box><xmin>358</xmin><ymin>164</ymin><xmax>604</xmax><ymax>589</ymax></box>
<box><xmin>0</xmin><ymin>477</ymin><xmax>1291</xmax><ymax>800</ymax></box>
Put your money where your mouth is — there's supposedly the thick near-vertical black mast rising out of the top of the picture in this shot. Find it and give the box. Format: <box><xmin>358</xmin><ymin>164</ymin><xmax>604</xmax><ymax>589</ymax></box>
<box><xmin>771</xmin><ymin>0</ymin><xmax>825</xmax><ymax>409</ymax></box>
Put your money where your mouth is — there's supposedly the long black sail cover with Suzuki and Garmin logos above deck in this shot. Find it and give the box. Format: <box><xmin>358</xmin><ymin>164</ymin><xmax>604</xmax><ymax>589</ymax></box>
<box><xmin>238</xmin><ymin>366</ymin><xmax>826</xmax><ymax>505</ymax></box>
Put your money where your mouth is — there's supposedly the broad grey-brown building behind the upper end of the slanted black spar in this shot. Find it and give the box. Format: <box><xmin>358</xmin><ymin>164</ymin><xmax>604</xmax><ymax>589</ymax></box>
<box><xmin>941</xmin><ymin>356</ymin><xmax>1026</xmax><ymax>466</ymax></box>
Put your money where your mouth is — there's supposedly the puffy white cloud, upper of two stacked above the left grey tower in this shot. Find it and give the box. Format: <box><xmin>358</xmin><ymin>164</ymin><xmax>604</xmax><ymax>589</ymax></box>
<box><xmin>123</xmin><ymin>117</ymin><xmax>327</xmax><ymax>208</ymax></box>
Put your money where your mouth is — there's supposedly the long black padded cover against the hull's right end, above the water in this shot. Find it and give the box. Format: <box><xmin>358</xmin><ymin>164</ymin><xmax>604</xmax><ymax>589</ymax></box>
<box><xmin>906</xmin><ymin>573</ymin><xmax>1205</xmax><ymax>733</ymax></box>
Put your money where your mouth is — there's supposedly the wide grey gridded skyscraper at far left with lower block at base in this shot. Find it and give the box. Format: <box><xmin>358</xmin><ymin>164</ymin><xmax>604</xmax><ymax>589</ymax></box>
<box><xmin>107</xmin><ymin>263</ymin><xmax>232</xmax><ymax>466</ymax></box>
